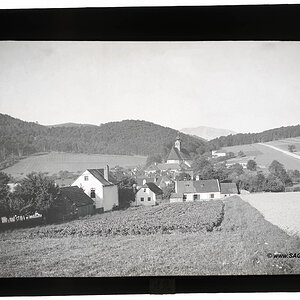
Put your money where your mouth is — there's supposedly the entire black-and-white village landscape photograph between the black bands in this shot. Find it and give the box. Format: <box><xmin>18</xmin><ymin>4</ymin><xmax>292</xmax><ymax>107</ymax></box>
<box><xmin>0</xmin><ymin>41</ymin><xmax>300</xmax><ymax>278</ymax></box>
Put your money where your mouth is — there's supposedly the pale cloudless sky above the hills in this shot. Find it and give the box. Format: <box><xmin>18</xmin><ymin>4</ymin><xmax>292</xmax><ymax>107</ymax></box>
<box><xmin>0</xmin><ymin>41</ymin><xmax>300</xmax><ymax>132</ymax></box>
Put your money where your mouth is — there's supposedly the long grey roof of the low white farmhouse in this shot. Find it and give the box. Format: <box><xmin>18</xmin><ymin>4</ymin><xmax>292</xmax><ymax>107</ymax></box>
<box><xmin>177</xmin><ymin>179</ymin><xmax>220</xmax><ymax>194</ymax></box>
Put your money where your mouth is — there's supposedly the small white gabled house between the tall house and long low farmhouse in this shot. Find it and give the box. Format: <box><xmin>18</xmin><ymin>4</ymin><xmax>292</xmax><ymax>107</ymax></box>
<box><xmin>132</xmin><ymin>182</ymin><xmax>163</xmax><ymax>206</ymax></box>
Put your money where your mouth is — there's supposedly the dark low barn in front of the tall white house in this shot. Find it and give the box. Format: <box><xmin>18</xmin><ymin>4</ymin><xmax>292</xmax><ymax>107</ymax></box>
<box><xmin>48</xmin><ymin>186</ymin><xmax>95</xmax><ymax>221</ymax></box>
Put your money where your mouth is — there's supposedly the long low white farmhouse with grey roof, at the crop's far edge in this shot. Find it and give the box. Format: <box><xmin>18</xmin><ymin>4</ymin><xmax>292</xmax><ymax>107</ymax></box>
<box><xmin>170</xmin><ymin>179</ymin><xmax>221</xmax><ymax>203</ymax></box>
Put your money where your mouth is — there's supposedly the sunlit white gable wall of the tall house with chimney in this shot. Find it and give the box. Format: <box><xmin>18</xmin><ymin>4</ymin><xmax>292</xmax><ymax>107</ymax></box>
<box><xmin>72</xmin><ymin>171</ymin><xmax>103</xmax><ymax>209</ymax></box>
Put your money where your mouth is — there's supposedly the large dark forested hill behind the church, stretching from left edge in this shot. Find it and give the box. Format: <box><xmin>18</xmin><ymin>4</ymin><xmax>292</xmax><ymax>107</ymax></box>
<box><xmin>0</xmin><ymin>114</ymin><xmax>206</xmax><ymax>161</ymax></box>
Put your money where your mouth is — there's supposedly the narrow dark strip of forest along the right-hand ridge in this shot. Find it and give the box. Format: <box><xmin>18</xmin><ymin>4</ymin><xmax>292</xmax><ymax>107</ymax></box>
<box><xmin>209</xmin><ymin>125</ymin><xmax>300</xmax><ymax>149</ymax></box>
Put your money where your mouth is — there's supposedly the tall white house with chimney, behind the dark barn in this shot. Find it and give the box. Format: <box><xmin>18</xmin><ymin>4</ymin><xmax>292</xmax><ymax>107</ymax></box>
<box><xmin>72</xmin><ymin>166</ymin><xmax>119</xmax><ymax>212</ymax></box>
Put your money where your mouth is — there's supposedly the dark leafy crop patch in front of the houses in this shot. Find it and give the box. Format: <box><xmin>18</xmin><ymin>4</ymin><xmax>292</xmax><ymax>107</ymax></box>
<box><xmin>0</xmin><ymin>200</ymin><xmax>224</xmax><ymax>239</ymax></box>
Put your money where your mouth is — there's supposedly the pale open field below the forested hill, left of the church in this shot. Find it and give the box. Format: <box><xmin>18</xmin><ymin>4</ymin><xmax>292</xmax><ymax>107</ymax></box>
<box><xmin>2</xmin><ymin>152</ymin><xmax>146</xmax><ymax>177</ymax></box>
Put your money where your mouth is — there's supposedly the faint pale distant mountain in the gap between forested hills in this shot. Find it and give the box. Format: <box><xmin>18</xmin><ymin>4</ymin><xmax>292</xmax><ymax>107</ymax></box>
<box><xmin>180</xmin><ymin>126</ymin><xmax>236</xmax><ymax>141</ymax></box>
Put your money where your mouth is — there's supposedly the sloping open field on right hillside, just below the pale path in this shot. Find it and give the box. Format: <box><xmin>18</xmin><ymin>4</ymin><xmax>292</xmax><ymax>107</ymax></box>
<box><xmin>222</xmin><ymin>144</ymin><xmax>300</xmax><ymax>171</ymax></box>
